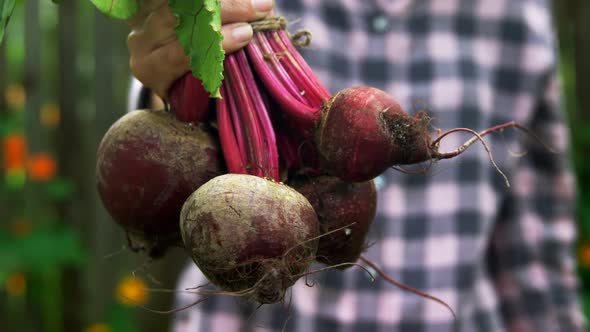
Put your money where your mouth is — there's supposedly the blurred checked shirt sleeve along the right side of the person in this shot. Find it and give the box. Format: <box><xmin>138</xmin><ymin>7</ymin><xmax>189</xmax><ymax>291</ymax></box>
<box><xmin>489</xmin><ymin>64</ymin><xmax>584</xmax><ymax>332</ymax></box>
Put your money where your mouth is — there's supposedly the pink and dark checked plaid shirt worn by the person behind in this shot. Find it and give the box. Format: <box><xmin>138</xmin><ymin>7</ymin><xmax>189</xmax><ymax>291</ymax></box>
<box><xmin>155</xmin><ymin>0</ymin><xmax>584</xmax><ymax>332</ymax></box>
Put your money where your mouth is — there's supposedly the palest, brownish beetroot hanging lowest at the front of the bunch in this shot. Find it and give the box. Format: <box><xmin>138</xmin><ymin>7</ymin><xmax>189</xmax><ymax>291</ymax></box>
<box><xmin>180</xmin><ymin>174</ymin><xmax>319</xmax><ymax>303</ymax></box>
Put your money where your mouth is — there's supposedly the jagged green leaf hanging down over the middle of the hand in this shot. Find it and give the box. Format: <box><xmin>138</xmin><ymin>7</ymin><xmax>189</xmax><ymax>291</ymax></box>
<box><xmin>170</xmin><ymin>0</ymin><xmax>225</xmax><ymax>98</ymax></box>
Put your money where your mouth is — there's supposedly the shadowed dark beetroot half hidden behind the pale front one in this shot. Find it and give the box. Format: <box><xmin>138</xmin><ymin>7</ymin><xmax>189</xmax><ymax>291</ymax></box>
<box><xmin>291</xmin><ymin>176</ymin><xmax>377</xmax><ymax>269</ymax></box>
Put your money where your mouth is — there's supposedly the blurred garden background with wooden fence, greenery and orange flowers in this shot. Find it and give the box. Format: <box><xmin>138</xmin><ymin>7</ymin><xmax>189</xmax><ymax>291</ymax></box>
<box><xmin>0</xmin><ymin>0</ymin><xmax>590</xmax><ymax>332</ymax></box>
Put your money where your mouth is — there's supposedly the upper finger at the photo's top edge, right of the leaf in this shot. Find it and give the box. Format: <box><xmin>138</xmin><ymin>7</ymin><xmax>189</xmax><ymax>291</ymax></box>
<box><xmin>221</xmin><ymin>0</ymin><xmax>274</xmax><ymax>24</ymax></box>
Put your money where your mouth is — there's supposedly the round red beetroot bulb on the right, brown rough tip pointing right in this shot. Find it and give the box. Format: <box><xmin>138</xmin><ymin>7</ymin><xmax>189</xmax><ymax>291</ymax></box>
<box><xmin>314</xmin><ymin>87</ymin><xmax>433</xmax><ymax>182</ymax></box>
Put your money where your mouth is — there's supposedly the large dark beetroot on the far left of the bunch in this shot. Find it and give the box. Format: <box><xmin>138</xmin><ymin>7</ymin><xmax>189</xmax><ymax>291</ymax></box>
<box><xmin>96</xmin><ymin>111</ymin><xmax>222</xmax><ymax>257</ymax></box>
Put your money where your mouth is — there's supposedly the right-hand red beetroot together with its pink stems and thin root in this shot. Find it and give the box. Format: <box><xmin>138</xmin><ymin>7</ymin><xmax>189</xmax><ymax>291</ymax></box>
<box><xmin>246</xmin><ymin>26</ymin><xmax>534</xmax><ymax>182</ymax></box>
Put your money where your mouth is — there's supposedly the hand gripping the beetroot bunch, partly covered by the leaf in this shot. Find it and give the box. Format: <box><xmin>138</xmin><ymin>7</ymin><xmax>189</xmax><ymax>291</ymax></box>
<box><xmin>127</xmin><ymin>0</ymin><xmax>274</xmax><ymax>98</ymax></box>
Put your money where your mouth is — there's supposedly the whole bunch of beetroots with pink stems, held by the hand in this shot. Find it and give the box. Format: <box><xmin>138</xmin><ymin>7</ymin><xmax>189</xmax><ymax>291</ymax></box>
<box><xmin>97</xmin><ymin>14</ymin><xmax>532</xmax><ymax>312</ymax></box>
